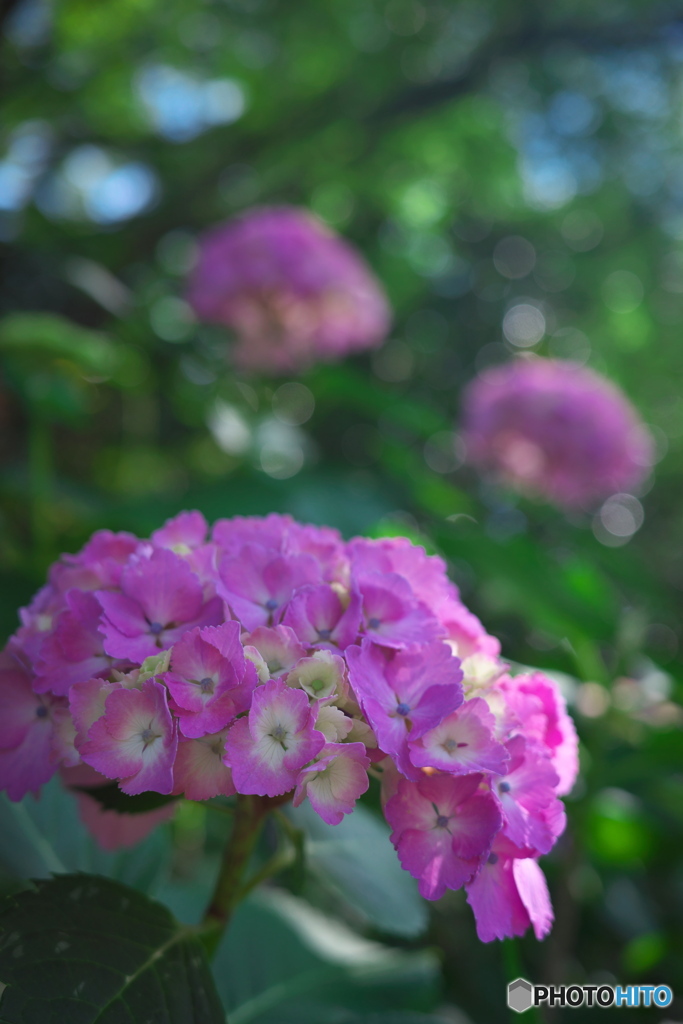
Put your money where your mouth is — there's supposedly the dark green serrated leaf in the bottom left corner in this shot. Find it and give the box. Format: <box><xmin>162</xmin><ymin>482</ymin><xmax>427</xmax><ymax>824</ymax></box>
<box><xmin>0</xmin><ymin>874</ymin><xmax>224</xmax><ymax>1024</ymax></box>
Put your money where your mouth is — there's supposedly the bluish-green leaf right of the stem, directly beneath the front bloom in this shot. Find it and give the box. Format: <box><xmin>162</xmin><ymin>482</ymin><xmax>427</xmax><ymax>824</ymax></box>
<box><xmin>288</xmin><ymin>802</ymin><xmax>427</xmax><ymax>937</ymax></box>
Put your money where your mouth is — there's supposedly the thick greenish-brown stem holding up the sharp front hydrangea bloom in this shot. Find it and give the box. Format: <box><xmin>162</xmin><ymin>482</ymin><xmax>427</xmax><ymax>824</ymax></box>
<box><xmin>202</xmin><ymin>796</ymin><xmax>269</xmax><ymax>956</ymax></box>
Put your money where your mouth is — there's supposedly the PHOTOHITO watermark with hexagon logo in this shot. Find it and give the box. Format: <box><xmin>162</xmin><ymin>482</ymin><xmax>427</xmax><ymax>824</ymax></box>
<box><xmin>508</xmin><ymin>978</ymin><xmax>674</xmax><ymax>1014</ymax></box>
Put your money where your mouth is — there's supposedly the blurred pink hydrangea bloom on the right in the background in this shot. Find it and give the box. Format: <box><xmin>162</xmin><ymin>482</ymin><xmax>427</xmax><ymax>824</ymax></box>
<box><xmin>464</xmin><ymin>357</ymin><xmax>653</xmax><ymax>508</ymax></box>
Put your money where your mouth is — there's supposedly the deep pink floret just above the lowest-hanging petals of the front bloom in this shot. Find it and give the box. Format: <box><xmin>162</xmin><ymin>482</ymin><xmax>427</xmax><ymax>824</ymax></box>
<box><xmin>384</xmin><ymin>774</ymin><xmax>502</xmax><ymax>899</ymax></box>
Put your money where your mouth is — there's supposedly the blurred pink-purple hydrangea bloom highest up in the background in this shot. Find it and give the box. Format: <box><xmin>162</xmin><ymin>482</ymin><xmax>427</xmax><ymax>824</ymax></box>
<box><xmin>187</xmin><ymin>207</ymin><xmax>390</xmax><ymax>374</ymax></box>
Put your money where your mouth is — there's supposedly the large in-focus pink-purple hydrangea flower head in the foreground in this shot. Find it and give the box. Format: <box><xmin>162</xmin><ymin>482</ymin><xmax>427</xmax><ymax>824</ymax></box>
<box><xmin>0</xmin><ymin>512</ymin><xmax>578</xmax><ymax>941</ymax></box>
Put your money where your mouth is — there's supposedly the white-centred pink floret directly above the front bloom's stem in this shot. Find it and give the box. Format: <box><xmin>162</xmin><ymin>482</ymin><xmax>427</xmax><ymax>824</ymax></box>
<box><xmin>225</xmin><ymin>679</ymin><xmax>325</xmax><ymax>797</ymax></box>
